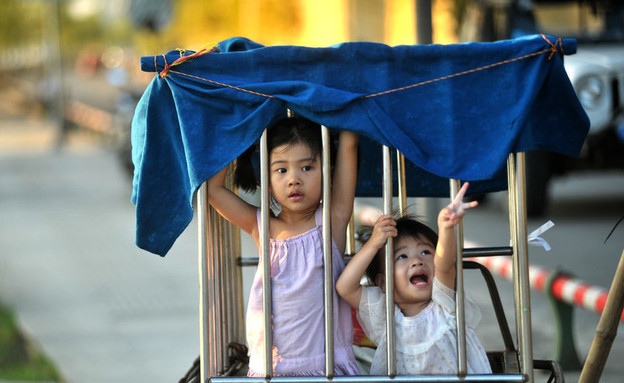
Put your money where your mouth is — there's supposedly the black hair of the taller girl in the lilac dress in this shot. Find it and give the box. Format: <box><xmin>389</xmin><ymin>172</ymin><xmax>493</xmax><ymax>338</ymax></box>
<box><xmin>234</xmin><ymin>117</ymin><xmax>335</xmax><ymax>192</ymax></box>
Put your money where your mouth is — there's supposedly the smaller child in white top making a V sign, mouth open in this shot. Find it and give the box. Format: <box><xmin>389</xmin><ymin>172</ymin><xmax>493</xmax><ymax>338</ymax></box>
<box><xmin>336</xmin><ymin>183</ymin><xmax>492</xmax><ymax>375</ymax></box>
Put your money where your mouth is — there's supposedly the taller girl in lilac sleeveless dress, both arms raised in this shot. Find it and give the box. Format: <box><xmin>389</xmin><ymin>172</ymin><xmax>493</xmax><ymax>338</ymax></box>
<box><xmin>208</xmin><ymin>118</ymin><xmax>359</xmax><ymax>376</ymax></box>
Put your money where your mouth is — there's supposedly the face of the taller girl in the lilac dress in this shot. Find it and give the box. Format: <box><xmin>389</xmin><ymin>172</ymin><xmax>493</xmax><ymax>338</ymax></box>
<box><xmin>270</xmin><ymin>143</ymin><xmax>322</xmax><ymax>211</ymax></box>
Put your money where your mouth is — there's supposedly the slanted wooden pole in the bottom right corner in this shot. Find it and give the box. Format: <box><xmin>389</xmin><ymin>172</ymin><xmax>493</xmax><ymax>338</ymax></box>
<box><xmin>579</xmin><ymin>251</ymin><xmax>624</xmax><ymax>383</ymax></box>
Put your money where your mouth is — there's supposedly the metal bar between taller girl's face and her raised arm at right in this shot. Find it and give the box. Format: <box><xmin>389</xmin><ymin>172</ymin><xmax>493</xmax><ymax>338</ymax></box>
<box><xmin>321</xmin><ymin>126</ymin><xmax>334</xmax><ymax>378</ymax></box>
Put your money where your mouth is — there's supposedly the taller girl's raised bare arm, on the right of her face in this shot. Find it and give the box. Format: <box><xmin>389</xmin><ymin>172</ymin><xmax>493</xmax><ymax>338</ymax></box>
<box><xmin>331</xmin><ymin>130</ymin><xmax>359</xmax><ymax>253</ymax></box>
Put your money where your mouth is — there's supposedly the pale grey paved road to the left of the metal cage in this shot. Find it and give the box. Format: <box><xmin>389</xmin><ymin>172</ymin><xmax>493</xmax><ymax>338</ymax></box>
<box><xmin>0</xmin><ymin>121</ymin><xmax>199</xmax><ymax>383</ymax></box>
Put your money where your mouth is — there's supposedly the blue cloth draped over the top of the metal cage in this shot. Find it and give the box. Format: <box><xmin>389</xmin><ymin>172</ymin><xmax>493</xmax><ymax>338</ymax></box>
<box><xmin>132</xmin><ymin>35</ymin><xmax>589</xmax><ymax>256</ymax></box>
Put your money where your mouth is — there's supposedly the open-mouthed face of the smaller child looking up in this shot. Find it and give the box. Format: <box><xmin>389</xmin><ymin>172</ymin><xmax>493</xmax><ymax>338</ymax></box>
<box><xmin>386</xmin><ymin>235</ymin><xmax>435</xmax><ymax>316</ymax></box>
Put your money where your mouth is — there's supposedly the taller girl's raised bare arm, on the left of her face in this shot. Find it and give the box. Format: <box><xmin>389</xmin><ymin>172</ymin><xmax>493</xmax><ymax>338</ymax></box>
<box><xmin>207</xmin><ymin>167</ymin><xmax>258</xmax><ymax>242</ymax></box>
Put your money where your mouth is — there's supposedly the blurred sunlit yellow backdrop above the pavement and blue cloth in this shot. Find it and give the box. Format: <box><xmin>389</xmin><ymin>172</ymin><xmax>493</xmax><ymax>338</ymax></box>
<box><xmin>0</xmin><ymin>0</ymin><xmax>463</xmax><ymax>152</ymax></box>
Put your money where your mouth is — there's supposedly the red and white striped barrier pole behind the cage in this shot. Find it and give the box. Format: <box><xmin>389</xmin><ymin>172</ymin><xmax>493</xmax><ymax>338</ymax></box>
<box><xmin>470</xmin><ymin>256</ymin><xmax>624</xmax><ymax>322</ymax></box>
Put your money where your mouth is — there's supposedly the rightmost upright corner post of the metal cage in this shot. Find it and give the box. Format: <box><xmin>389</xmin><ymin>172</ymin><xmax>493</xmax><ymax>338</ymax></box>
<box><xmin>514</xmin><ymin>153</ymin><xmax>533</xmax><ymax>383</ymax></box>
